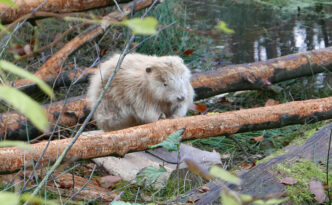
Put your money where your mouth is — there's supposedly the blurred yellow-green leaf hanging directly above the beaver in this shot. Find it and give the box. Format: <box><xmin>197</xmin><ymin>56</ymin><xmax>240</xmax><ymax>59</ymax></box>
<box><xmin>121</xmin><ymin>16</ymin><xmax>158</xmax><ymax>35</ymax></box>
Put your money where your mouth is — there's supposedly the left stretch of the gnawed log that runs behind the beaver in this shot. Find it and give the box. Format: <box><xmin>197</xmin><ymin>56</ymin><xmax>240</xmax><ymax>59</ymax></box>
<box><xmin>0</xmin><ymin>97</ymin><xmax>90</xmax><ymax>140</ymax></box>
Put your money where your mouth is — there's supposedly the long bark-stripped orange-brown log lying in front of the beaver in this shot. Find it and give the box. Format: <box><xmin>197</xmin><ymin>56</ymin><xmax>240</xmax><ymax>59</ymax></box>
<box><xmin>0</xmin><ymin>97</ymin><xmax>332</xmax><ymax>172</ymax></box>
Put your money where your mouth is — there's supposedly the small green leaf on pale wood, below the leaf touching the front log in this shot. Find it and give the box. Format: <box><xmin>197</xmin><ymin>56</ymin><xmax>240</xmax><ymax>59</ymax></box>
<box><xmin>136</xmin><ymin>166</ymin><xmax>166</xmax><ymax>186</ymax></box>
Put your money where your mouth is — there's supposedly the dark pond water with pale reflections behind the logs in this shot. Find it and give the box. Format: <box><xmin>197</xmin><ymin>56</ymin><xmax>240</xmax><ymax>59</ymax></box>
<box><xmin>184</xmin><ymin>0</ymin><xmax>332</xmax><ymax>67</ymax></box>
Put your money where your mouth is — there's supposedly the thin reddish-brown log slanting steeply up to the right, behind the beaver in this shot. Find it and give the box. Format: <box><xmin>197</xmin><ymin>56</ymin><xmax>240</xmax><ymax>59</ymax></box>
<box><xmin>13</xmin><ymin>0</ymin><xmax>153</xmax><ymax>87</ymax></box>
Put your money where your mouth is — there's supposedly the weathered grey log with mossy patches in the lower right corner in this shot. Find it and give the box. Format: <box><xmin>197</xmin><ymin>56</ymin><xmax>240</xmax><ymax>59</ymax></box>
<box><xmin>176</xmin><ymin>124</ymin><xmax>332</xmax><ymax>205</ymax></box>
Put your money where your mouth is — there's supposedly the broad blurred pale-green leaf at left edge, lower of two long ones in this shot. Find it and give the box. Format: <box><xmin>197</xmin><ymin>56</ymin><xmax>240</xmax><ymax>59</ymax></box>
<box><xmin>0</xmin><ymin>86</ymin><xmax>48</xmax><ymax>130</ymax></box>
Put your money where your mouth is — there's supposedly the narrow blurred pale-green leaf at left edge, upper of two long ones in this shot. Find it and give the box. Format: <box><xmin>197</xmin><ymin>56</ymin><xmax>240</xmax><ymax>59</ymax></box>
<box><xmin>0</xmin><ymin>60</ymin><xmax>54</xmax><ymax>97</ymax></box>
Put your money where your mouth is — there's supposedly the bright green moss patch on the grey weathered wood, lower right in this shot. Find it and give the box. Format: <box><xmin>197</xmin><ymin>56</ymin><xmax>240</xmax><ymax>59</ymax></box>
<box><xmin>276</xmin><ymin>161</ymin><xmax>332</xmax><ymax>204</ymax></box>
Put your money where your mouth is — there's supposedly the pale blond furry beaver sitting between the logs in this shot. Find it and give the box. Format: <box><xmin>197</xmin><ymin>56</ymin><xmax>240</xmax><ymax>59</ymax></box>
<box><xmin>87</xmin><ymin>53</ymin><xmax>194</xmax><ymax>131</ymax></box>
